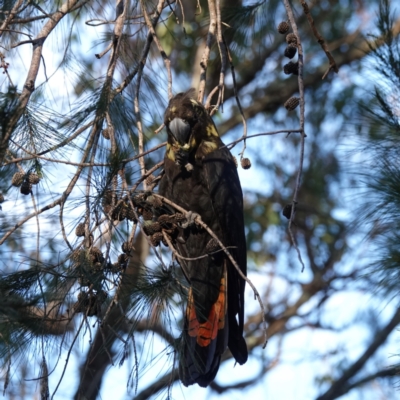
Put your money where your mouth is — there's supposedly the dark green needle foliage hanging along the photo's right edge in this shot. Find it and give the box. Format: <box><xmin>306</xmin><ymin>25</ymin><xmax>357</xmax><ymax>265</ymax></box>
<box><xmin>358</xmin><ymin>0</ymin><xmax>400</xmax><ymax>295</ymax></box>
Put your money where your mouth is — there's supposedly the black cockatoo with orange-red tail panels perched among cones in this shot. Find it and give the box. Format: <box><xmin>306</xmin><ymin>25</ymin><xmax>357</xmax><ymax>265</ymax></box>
<box><xmin>159</xmin><ymin>89</ymin><xmax>248</xmax><ymax>387</ymax></box>
